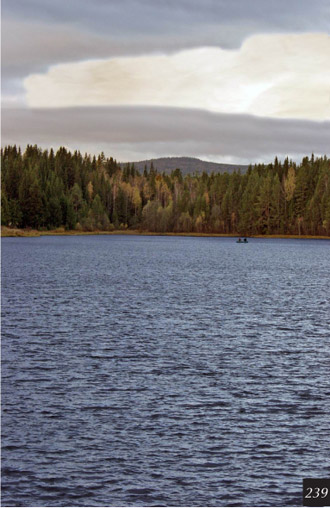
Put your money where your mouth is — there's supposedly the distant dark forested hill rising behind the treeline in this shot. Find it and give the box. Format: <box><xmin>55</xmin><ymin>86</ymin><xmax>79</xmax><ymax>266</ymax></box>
<box><xmin>120</xmin><ymin>157</ymin><xmax>248</xmax><ymax>175</ymax></box>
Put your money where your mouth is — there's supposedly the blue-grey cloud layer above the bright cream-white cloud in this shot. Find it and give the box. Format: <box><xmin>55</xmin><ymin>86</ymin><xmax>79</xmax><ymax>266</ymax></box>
<box><xmin>2</xmin><ymin>0</ymin><xmax>330</xmax><ymax>80</ymax></box>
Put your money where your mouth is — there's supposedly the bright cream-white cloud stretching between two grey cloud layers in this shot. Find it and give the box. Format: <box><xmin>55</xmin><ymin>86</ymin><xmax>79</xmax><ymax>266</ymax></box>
<box><xmin>24</xmin><ymin>34</ymin><xmax>330</xmax><ymax>120</ymax></box>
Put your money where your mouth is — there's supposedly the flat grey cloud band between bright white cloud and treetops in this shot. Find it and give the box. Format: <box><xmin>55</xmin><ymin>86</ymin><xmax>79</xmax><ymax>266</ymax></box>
<box><xmin>2</xmin><ymin>107</ymin><xmax>330</xmax><ymax>163</ymax></box>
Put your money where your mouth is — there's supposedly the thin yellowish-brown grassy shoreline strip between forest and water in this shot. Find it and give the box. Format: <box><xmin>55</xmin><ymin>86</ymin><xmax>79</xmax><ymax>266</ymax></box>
<box><xmin>1</xmin><ymin>226</ymin><xmax>330</xmax><ymax>240</ymax></box>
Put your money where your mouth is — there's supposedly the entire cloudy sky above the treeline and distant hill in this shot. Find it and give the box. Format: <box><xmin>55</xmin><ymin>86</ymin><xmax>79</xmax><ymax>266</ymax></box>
<box><xmin>2</xmin><ymin>0</ymin><xmax>330</xmax><ymax>164</ymax></box>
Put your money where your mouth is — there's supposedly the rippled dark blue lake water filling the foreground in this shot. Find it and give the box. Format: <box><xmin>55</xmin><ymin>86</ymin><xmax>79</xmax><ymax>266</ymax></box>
<box><xmin>2</xmin><ymin>235</ymin><xmax>330</xmax><ymax>506</ymax></box>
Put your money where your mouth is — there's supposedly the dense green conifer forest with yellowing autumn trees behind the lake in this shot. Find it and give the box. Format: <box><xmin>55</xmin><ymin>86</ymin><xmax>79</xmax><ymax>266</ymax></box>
<box><xmin>1</xmin><ymin>145</ymin><xmax>330</xmax><ymax>236</ymax></box>
